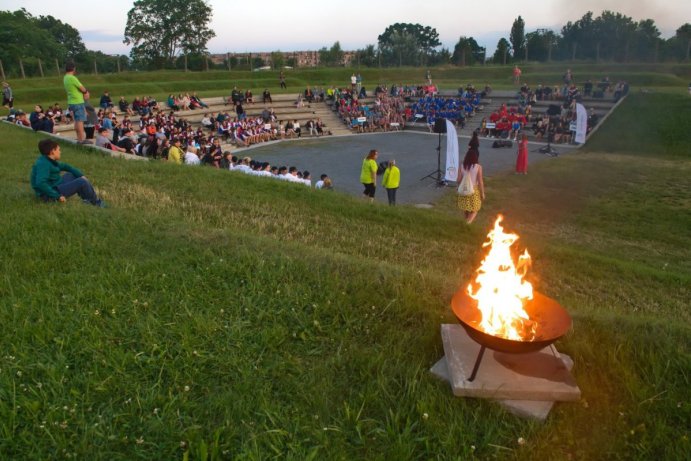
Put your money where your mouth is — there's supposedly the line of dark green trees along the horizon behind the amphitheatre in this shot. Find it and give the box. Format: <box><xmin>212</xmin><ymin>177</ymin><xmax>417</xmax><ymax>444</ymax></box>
<box><xmin>0</xmin><ymin>0</ymin><xmax>691</xmax><ymax>76</ymax></box>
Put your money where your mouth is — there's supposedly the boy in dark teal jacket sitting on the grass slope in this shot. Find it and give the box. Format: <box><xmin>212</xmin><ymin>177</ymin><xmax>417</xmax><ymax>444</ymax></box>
<box><xmin>31</xmin><ymin>139</ymin><xmax>105</xmax><ymax>208</ymax></box>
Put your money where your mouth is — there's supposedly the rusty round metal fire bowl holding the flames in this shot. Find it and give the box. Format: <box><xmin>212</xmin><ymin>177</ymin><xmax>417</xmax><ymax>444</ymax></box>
<box><xmin>451</xmin><ymin>289</ymin><xmax>571</xmax><ymax>354</ymax></box>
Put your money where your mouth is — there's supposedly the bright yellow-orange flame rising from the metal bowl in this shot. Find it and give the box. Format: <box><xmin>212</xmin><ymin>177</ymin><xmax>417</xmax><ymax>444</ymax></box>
<box><xmin>468</xmin><ymin>215</ymin><xmax>537</xmax><ymax>341</ymax></box>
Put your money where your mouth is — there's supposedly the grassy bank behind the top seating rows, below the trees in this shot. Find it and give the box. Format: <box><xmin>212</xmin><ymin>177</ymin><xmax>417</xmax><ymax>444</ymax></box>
<box><xmin>5</xmin><ymin>63</ymin><xmax>691</xmax><ymax>115</ymax></box>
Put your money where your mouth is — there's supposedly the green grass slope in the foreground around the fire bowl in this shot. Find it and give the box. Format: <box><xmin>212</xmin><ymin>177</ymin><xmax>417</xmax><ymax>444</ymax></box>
<box><xmin>0</xmin><ymin>85</ymin><xmax>691</xmax><ymax>460</ymax></box>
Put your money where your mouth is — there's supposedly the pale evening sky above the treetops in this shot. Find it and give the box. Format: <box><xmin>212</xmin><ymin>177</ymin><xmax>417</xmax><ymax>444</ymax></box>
<box><xmin>5</xmin><ymin>0</ymin><xmax>691</xmax><ymax>55</ymax></box>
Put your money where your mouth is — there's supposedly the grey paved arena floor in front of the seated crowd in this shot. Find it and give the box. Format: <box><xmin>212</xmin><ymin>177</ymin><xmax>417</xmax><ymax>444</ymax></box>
<box><xmin>242</xmin><ymin>131</ymin><xmax>575</xmax><ymax>204</ymax></box>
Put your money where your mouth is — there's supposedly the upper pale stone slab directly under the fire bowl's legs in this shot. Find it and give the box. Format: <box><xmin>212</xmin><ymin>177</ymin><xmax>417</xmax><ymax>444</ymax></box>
<box><xmin>441</xmin><ymin>324</ymin><xmax>581</xmax><ymax>403</ymax></box>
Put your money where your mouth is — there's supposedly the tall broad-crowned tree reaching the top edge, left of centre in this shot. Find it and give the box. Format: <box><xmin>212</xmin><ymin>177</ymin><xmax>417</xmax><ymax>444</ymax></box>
<box><xmin>123</xmin><ymin>0</ymin><xmax>216</xmax><ymax>67</ymax></box>
